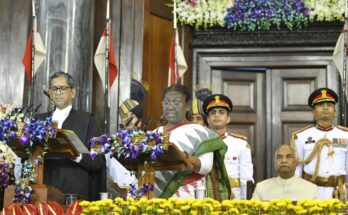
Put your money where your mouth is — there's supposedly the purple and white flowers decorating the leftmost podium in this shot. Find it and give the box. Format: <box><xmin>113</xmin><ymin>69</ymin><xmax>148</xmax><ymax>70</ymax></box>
<box><xmin>0</xmin><ymin>105</ymin><xmax>55</xmax><ymax>205</ymax></box>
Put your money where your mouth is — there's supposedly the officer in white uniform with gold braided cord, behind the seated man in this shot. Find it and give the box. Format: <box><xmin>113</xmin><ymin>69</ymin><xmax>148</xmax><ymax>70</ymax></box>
<box><xmin>291</xmin><ymin>88</ymin><xmax>348</xmax><ymax>199</ymax></box>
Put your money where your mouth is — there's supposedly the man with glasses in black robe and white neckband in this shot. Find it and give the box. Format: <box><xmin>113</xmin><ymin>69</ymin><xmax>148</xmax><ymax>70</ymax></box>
<box><xmin>37</xmin><ymin>72</ymin><xmax>106</xmax><ymax>200</ymax></box>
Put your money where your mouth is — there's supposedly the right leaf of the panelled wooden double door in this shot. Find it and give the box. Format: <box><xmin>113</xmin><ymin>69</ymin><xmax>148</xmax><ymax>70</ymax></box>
<box><xmin>267</xmin><ymin>68</ymin><xmax>328</xmax><ymax>176</ymax></box>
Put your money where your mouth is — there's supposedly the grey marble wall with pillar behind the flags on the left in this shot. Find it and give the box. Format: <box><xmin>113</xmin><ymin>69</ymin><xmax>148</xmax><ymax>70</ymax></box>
<box><xmin>0</xmin><ymin>0</ymin><xmax>144</xmax><ymax>131</ymax></box>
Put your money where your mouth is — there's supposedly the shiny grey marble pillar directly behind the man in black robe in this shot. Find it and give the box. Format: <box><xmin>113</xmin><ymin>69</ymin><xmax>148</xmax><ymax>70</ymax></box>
<box><xmin>32</xmin><ymin>0</ymin><xmax>95</xmax><ymax>112</ymax></box>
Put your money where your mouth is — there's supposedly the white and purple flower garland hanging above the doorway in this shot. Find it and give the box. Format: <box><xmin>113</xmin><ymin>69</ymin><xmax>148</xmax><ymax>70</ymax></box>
<box><xmin>176</xmin><ymin>0</ymin><xmax>345</xmax><ymax>31</ymax></box>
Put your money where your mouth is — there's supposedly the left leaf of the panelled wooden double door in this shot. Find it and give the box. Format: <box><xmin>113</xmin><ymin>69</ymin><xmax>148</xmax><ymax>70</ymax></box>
<box><xmin>212</xmin><ymin>70</ymin><xmax>266</xmax><ymax>181</ymax></box>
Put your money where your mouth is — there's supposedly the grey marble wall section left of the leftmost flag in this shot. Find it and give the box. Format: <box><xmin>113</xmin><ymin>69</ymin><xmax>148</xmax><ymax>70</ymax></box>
<box><xmin>0</xmin><ymin>0</ymin><xmax>30</xmax><ymax>106</ymax></box>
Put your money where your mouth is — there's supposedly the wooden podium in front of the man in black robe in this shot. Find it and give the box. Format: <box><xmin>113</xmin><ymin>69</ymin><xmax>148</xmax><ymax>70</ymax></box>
<box><xmin>4</xmin><ymin>129</ymin><xmax>89</xmax><ymax>207</ymax></box>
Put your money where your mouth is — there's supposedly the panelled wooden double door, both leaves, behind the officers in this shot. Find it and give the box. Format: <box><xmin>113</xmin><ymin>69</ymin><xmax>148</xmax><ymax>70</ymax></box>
<box><xmin>212</xmin><ymin>68</ymin><xmax>335</xmax><ymax>181</ymax></box>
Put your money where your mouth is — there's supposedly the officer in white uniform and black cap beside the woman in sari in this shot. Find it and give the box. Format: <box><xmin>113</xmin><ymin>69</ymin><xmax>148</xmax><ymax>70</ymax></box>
<box><xmin>203</xmin><ymin>94</ymin><xmax>254</xmax><ymax>199</ymax></box>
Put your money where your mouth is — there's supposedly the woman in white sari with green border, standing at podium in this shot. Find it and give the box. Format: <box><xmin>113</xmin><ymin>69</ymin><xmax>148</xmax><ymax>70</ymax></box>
<box><xmin>155</xmin><ymin>84</ymin><xmax>230</xmax><ymax>199</ymax></box>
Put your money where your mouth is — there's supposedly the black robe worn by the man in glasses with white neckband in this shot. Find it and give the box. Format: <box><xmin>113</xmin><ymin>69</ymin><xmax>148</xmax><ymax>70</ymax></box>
<box><xmin>36</xmin><ymin>108</ymin><xmax>106</xmax><ymax>201</ymax></box>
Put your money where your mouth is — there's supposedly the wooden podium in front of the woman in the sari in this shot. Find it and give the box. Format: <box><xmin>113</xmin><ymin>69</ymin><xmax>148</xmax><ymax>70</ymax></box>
<box><xmin>116</xmin><ymin>143</ymin><xmax>193</xmax><ymax>198</ymax></box>
